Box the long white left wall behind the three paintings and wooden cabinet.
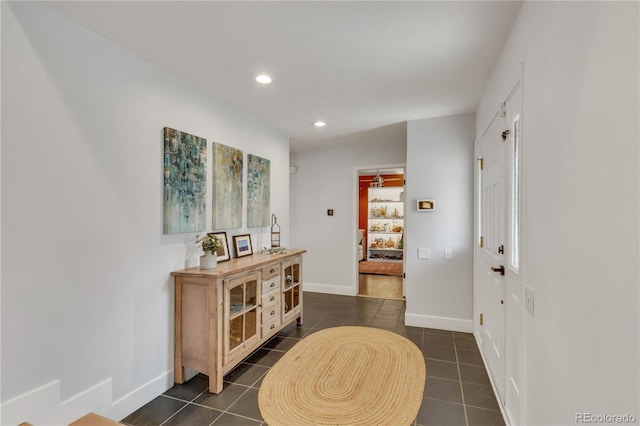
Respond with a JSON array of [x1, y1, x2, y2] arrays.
[[1, 2, 289, 424]]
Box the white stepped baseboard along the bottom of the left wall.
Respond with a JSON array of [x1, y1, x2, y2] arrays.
[[0, 370, 173, 426]]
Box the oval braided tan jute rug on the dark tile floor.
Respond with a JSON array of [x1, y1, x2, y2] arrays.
[[258, 327, 426, 426]]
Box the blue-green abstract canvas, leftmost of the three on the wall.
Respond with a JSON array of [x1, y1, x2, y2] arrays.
[[163, 127, 207, 234]]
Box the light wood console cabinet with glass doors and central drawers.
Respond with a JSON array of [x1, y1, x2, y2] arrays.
[[171, 250, 305, 394]]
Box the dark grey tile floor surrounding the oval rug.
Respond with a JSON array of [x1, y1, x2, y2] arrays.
[[121, 293, 504, 426]]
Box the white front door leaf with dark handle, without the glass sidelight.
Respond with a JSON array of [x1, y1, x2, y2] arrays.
[[476, 110, 507, 400]]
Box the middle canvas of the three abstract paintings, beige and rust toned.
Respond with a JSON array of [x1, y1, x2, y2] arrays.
[[212, 143, 244, 229]]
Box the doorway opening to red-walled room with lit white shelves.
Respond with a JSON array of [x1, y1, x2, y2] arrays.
[[356, 167, 404, 300]]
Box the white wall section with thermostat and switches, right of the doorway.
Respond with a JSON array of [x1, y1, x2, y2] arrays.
[[405, 114, 475, 331]]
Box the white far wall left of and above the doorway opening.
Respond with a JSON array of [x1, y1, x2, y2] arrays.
[[290, 123, 406, 295]]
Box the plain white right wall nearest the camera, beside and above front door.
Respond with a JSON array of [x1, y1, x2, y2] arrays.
[[477, 2, 640, 425]]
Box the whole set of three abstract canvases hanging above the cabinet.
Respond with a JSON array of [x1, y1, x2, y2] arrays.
[[163, 127, 271, 238]]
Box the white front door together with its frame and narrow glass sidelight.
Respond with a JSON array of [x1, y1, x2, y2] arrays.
[[475, 82, 524, 424]]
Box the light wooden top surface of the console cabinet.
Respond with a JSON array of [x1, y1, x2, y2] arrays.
[[171, 249, 306, 278]]
